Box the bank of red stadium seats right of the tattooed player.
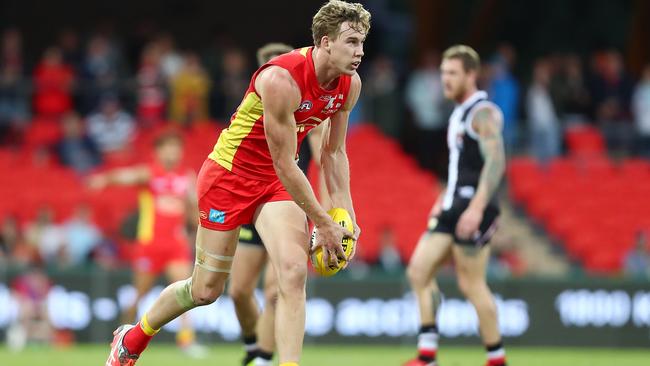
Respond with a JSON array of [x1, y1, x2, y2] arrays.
[[508, 155, 650, 273]]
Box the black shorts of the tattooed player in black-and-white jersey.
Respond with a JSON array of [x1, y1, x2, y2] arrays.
[[427, 198, 499, 247]]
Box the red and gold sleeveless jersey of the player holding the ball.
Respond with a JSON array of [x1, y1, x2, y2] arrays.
[[209, 47, 351, 181]]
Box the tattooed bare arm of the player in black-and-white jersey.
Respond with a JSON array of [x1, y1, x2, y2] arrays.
[[456, 107, 506, 239]]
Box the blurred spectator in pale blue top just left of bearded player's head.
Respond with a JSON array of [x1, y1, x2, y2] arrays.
[[405, 50, 447, 176]]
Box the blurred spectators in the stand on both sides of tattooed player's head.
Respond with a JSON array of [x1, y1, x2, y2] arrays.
[[363, 43, 650, 175]]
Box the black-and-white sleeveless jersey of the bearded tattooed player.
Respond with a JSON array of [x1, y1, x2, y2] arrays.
[[442, 90, 503, 210]]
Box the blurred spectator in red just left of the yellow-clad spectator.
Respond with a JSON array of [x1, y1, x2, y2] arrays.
[[136, 43, 166, 126]]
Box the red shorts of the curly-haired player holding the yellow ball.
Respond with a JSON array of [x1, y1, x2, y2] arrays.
[[196, 159, 293, 231]]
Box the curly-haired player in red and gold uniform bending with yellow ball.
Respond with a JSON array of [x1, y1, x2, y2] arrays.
[[106, 0, 370, 366]]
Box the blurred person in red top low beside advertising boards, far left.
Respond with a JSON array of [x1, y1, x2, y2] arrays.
[[7, 268, 54, 351]]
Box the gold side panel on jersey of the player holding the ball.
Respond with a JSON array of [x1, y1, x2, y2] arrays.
[[208, 92, 264, 171]]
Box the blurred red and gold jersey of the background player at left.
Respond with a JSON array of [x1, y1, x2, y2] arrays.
[[138, 163, 192, 244]]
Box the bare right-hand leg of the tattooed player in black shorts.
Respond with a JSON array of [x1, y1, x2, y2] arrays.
[[453, 245, 501, 345]]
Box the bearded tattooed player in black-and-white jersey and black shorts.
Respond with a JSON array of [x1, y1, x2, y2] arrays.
[[405, 45, 506, 366]]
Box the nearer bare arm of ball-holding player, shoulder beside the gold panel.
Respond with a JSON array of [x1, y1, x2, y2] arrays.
[[255, 66, 349, 262]]
